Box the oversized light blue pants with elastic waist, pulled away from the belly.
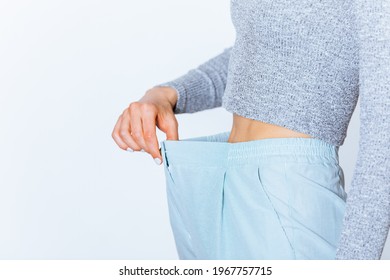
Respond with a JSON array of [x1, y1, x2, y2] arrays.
[[160, 131, 346, 259]]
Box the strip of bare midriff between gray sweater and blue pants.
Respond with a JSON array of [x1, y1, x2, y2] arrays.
[[227, 113, 311, 143]]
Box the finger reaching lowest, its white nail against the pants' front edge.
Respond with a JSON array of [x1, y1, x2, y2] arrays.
[[142, 111, 162, 164]]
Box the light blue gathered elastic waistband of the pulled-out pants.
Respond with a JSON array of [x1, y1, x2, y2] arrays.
[[160, 131, 338, 166]]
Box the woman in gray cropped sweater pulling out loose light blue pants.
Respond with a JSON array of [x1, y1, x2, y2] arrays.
[[112, 0, 390, 259]]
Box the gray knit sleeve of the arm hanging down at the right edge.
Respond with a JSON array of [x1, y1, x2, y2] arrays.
[[336, 0, 390, 259]]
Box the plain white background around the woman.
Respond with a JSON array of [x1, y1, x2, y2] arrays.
[[0, 0, 390, 259]]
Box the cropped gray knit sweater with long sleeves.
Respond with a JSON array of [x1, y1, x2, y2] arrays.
[[159, 0, 390, 259]]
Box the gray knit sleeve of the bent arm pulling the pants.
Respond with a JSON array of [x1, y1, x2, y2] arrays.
[[157, 47, 232, 114]]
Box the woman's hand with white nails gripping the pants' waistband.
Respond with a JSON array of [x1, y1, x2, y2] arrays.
[[112, 87, 179, 165]]
